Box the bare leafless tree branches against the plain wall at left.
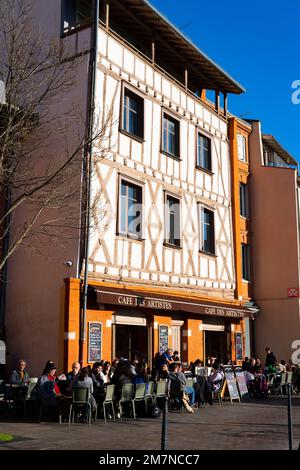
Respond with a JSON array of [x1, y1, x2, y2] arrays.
[[0, 0, 112, 271]]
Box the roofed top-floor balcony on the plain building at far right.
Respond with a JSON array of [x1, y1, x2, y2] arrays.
[[262, 134, 298, 170]]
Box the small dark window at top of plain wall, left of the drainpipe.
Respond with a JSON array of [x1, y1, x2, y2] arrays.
[[63, 0, 92, 32]]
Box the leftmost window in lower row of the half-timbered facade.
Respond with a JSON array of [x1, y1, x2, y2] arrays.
[[119, 180, 142, 238]]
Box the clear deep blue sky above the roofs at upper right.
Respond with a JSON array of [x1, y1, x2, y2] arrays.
[[149, 0, 300, 163]]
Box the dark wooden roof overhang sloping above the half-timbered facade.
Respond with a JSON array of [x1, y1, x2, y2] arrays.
[[109, 0, 245, 94]]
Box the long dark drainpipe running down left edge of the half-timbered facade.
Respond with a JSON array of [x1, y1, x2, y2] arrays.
[[79, 0, 100, 364]]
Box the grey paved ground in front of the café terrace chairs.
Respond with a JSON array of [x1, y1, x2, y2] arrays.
[[0, 396, 300, 450]]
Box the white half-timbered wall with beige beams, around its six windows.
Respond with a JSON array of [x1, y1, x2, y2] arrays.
[[89, 27, 235, 298]]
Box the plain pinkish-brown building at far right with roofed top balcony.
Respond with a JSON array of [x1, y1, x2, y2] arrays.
[[249, 121, 300, 360]]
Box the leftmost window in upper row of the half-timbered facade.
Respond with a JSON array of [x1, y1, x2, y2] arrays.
[[123, 88, 144, 139]]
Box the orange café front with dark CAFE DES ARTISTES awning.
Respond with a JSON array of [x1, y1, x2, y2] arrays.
[[65, 280, 253, 367]]
